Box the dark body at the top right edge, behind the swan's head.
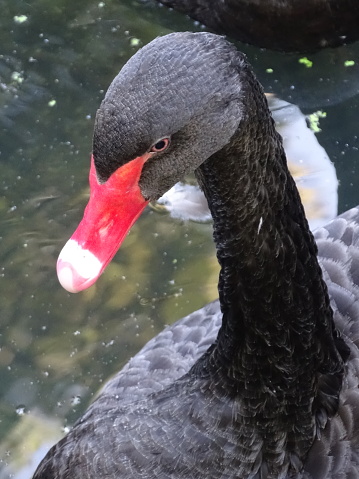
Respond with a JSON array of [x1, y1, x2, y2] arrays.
[[158, 0, 359, 52]]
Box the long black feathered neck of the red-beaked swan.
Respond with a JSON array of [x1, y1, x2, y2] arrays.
[[195, 79, 346, 472]]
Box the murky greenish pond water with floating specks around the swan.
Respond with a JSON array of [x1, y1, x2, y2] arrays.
[[0, 0, 359, 479]]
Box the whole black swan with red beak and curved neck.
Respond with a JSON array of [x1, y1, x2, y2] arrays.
[[34, 33, 359, 479]]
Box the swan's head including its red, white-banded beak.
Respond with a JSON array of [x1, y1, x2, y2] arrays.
[[57, 33, 248, 292]]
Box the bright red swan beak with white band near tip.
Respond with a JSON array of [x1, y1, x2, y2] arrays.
[[57, 154, 149, 293]]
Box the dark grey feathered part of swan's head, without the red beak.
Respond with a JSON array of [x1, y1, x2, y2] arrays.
[[93, 32, 243, 200]]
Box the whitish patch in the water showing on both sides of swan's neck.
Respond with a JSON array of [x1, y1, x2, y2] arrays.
[[154, 94, 338, 230]]
